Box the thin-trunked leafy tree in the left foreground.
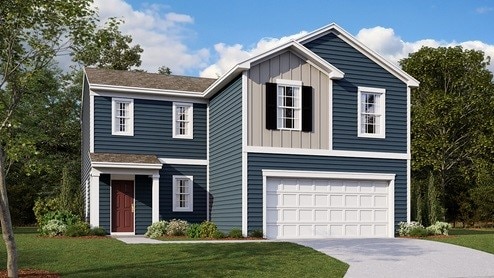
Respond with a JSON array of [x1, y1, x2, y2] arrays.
[[0, 0, 96, 277]]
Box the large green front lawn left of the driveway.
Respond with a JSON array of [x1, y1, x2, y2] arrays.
[[0, 228, 348, 277]]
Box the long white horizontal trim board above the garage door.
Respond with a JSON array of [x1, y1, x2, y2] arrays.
[[246, 146, 410, 160]]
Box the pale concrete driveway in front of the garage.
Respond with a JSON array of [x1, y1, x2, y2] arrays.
[[292, 238, 494, 278]]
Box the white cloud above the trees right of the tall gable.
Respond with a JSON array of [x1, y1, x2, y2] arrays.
[[356, 26, 494, 72]]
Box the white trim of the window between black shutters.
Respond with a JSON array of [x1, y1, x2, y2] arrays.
[[275, 79, 302, 131]]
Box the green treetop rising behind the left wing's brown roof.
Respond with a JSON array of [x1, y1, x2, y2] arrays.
[[75, 18, 143, 70]]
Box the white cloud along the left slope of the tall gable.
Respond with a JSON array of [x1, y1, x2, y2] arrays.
[[200, 31, 307, 78]]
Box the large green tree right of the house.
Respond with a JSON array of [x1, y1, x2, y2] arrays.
[[400, 46, 494, 224]]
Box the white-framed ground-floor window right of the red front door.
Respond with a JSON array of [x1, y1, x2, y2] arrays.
[[173, 176, 194, 211]]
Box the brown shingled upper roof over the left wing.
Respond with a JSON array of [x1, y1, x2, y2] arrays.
[[84, 68, 216, 94]]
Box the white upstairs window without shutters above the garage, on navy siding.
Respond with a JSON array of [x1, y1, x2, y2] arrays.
[[357, 87, 386, 138]]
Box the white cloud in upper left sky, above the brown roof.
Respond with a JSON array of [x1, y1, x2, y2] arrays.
[[94, 0, 210, 74]]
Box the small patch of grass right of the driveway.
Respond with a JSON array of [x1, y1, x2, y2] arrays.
[[427, 229, 494, 254]]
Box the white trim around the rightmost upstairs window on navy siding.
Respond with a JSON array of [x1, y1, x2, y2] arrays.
[[357, 86, 386, 138]]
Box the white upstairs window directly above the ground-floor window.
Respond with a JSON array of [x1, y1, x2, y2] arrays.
[[172, 102, 194, 139]]
